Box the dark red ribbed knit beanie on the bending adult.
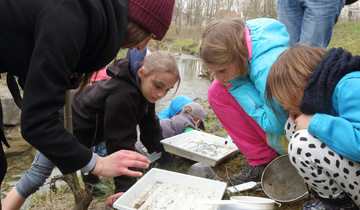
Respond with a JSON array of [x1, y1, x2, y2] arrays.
[[127, 0, 175, 40]]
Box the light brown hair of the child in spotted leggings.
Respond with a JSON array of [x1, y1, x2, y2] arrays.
[[265, 45, 326, 113]]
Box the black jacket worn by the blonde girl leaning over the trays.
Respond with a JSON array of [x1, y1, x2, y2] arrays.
[[72, 59, 163, 192]]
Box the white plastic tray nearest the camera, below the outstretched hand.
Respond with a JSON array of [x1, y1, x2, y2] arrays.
[[113, 168, 227, 210]]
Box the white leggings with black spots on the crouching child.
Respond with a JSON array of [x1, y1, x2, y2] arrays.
[[285, 129, 360, 208]]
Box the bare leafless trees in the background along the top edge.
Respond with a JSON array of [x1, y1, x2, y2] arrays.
[[170, 0, 276, 40]]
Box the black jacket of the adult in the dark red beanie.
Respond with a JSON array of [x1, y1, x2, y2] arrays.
[[0, 0, 127, 174]]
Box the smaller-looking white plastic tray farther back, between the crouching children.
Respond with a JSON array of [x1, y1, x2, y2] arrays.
[[161, 130, 239, 166]]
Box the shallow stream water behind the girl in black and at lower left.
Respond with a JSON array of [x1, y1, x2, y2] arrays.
[[1, 55, 210, 203]]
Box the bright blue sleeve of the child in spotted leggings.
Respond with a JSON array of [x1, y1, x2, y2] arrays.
[[308, 74, 360, 162]]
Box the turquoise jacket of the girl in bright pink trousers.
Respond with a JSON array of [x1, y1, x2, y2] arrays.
[[229, 18, 289, 135]]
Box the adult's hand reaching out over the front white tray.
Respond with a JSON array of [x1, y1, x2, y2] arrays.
[[91, 150, 150, 177]]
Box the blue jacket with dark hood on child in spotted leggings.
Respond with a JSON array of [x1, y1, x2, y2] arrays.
[[300, 48, 360, 162]]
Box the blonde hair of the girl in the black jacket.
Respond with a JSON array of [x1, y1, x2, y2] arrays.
[[142, 50, 181, 94]]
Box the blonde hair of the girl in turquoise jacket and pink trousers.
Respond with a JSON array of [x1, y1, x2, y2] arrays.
[[200, 18, 249, 77]]
